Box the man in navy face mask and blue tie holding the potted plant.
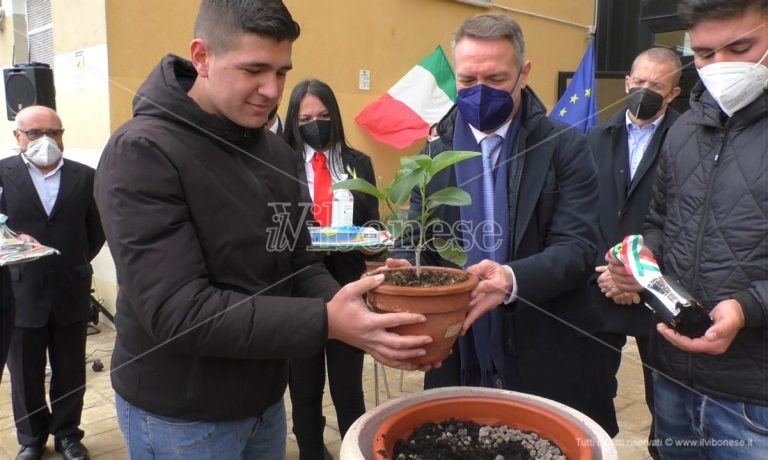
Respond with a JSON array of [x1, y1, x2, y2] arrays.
[[390, 14, 618, 434]]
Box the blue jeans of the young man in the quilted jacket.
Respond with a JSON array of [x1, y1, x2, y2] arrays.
[[653, 373, 768, 460]]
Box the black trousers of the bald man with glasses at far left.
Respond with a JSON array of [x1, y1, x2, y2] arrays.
[[8, 319, 87, 446]]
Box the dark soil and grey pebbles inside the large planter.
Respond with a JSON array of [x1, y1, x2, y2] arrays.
[[390, 419, 567, 460]]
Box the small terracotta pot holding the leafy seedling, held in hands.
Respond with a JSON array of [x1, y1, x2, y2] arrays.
[[368, 267, 479, 364]]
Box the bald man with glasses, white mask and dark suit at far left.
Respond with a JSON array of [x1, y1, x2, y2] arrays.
[[0, 106, 104, 459]]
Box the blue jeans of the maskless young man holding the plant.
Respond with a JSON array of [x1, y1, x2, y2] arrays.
[[115, 393, 286, 460]]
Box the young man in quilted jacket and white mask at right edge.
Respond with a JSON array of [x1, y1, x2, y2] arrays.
[[610, 0, 768, 459]]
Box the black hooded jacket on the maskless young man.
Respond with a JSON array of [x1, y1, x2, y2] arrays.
[[95, 55, 338, 421]]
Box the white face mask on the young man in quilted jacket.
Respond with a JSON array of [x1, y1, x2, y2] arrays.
[[698, 50, 768, 117]]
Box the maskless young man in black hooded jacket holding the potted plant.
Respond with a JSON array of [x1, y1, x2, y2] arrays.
[[96, 0, 431, 459]]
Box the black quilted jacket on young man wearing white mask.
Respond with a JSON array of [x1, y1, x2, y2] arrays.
[[644, 84, 768, 404]]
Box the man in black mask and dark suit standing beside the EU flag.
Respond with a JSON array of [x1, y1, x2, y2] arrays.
[[587, 48, 681, 456]]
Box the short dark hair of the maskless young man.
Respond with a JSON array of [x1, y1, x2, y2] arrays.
[[195, 0, 301, 53]]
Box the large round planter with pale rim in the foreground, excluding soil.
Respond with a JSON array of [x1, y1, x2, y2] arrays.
[[341, 387, 618, 460]]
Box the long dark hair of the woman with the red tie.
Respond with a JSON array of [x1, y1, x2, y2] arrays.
[[283, 79, 351, 177]]
